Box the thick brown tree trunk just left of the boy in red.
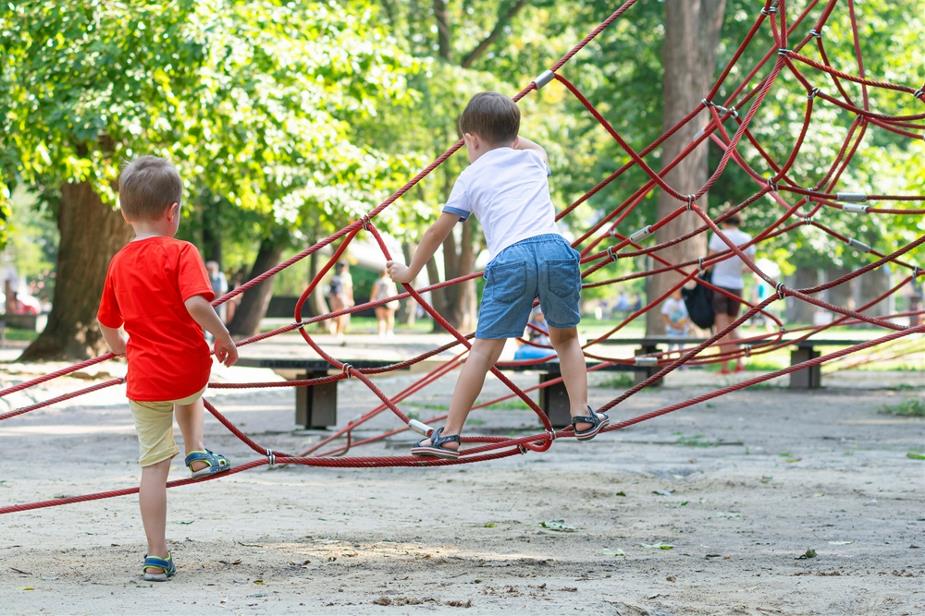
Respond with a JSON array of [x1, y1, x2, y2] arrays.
[[20, 182, 132, 361]]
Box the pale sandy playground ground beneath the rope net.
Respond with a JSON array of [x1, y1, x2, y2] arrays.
[[0, 344, 925, 616]]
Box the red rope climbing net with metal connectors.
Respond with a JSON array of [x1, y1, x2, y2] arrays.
[[0, 0, 925, 514]]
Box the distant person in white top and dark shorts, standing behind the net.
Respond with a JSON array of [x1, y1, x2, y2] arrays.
[[707, 214, 755, 374]]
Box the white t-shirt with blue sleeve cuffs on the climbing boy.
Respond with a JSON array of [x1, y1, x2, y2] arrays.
[[443, 148, 559, 259]]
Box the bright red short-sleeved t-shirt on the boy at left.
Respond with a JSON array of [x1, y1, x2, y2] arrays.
[[97, 236, 215, 402]]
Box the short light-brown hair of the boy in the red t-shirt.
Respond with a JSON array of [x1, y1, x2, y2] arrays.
[[119, 156, 183, 220]]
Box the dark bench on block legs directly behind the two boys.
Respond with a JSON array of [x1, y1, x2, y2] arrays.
[[235, 357, 639, 430]]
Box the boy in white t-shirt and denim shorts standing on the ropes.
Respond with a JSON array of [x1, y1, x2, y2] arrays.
[[387, 92, 609, 458]]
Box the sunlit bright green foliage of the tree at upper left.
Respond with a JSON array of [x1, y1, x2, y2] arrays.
[[0, 0, 420, 250]]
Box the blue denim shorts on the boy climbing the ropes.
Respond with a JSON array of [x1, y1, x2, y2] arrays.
[[475, 233, 581, 339]]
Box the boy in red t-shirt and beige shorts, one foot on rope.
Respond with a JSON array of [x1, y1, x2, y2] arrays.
[[97, 156, 238, 582]]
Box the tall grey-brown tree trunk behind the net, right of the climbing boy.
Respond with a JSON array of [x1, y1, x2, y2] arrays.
[[648, 0, 726, 336]]
